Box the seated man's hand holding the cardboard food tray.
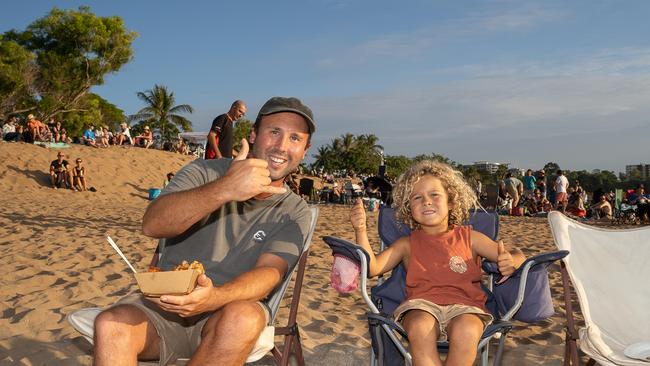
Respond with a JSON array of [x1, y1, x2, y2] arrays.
[[147, 274, 219, 318]]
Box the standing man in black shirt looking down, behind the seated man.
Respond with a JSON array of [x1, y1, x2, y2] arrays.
[[205, 100, 246, 159]]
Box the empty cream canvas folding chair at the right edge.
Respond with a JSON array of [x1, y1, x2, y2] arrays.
[[548, 212, 650, 365]]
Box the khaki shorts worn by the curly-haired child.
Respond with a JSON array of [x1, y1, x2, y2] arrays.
[[393, 299, 494, 342]]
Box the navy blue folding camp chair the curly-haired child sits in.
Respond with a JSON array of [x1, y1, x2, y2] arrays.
[[323, 207, 568, 366]]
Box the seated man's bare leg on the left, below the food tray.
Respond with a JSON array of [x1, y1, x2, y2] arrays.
[[93, 305, 160, 366]]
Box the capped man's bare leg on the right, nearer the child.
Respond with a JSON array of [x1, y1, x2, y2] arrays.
[[188, 301, 266, 366]]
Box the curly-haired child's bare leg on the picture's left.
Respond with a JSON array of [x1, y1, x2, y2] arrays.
[[402, 310, 442, 366]]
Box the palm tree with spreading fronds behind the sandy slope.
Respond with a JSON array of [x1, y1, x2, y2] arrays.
[[129, 85, 194, 142]]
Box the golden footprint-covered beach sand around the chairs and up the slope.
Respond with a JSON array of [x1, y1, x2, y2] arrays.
[[0, 143, 588, 366]]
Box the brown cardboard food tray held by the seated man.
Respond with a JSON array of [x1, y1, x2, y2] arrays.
[[135, 269, 201, 297]]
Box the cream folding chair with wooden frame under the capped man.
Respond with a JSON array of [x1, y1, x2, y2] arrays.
[[67, 206, 318, 366]]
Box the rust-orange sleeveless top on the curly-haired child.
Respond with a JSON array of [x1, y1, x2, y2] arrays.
[[406, 226, 487, 311]]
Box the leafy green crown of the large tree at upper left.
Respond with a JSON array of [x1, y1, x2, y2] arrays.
[[0, 6, 136, 120]]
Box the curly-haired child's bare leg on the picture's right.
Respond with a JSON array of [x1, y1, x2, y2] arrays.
[[445, 314, 483, 366]]
